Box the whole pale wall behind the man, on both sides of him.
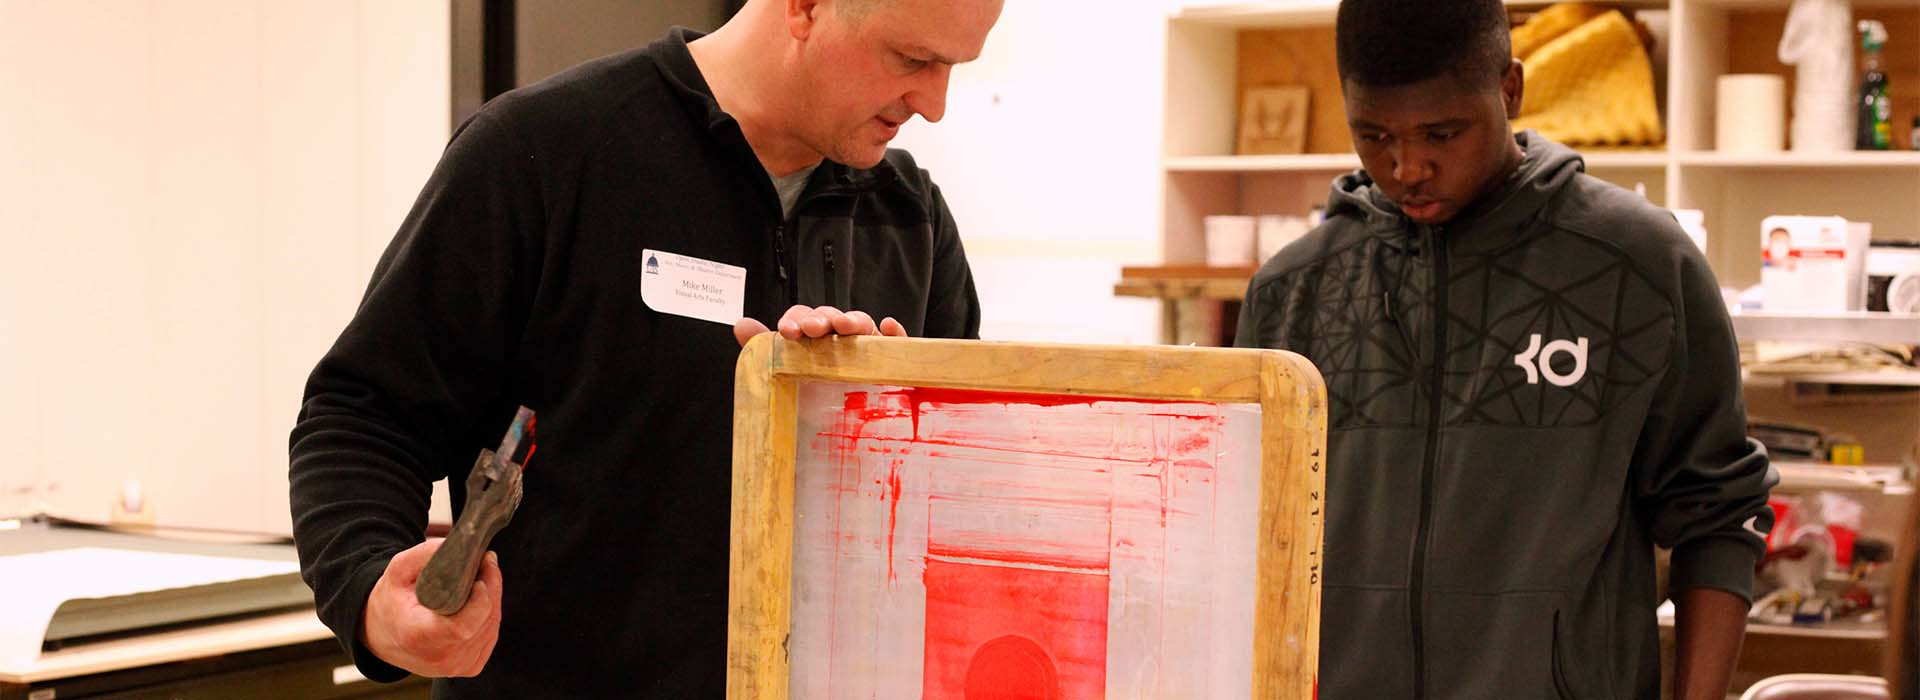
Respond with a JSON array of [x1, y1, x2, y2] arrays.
[[0, 0, 1177, 531]]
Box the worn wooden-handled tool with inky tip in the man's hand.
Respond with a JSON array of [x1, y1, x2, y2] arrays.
[[413, 407, 534, 616]]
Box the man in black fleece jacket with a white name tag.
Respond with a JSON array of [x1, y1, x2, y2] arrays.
[[288, 0, 1000, 698]]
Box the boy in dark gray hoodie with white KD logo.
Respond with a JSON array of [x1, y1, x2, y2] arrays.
[[1238, 0, 1778, 700]]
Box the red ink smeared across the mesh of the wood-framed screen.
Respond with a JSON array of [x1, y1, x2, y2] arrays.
[[812, 387, 1227, 700]]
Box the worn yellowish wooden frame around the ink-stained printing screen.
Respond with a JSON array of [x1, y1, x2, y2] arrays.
[[728, 334, 1327, 700]]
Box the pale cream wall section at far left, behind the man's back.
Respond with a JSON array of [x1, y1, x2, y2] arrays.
[[0, 0, 451, 531]]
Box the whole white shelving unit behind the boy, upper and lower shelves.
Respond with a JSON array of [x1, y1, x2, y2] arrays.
[[1160, 0, 1920, 675]]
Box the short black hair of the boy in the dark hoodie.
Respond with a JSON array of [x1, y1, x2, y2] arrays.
[[1334, 0, 1513, 88]]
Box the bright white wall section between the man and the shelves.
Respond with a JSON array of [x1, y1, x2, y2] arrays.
[[895, 0, 1181, 343]]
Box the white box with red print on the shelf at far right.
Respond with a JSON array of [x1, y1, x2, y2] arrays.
[[1761, 217, 1872, 313]]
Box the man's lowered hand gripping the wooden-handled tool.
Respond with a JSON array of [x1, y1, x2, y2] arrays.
[[359, 537, 503, 679]]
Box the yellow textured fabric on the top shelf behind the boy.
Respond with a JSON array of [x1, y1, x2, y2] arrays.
[[1513, 8, 1667, 146]]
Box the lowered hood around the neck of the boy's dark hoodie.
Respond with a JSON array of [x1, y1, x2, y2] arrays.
[[1327, 128, 1586, 253]]
